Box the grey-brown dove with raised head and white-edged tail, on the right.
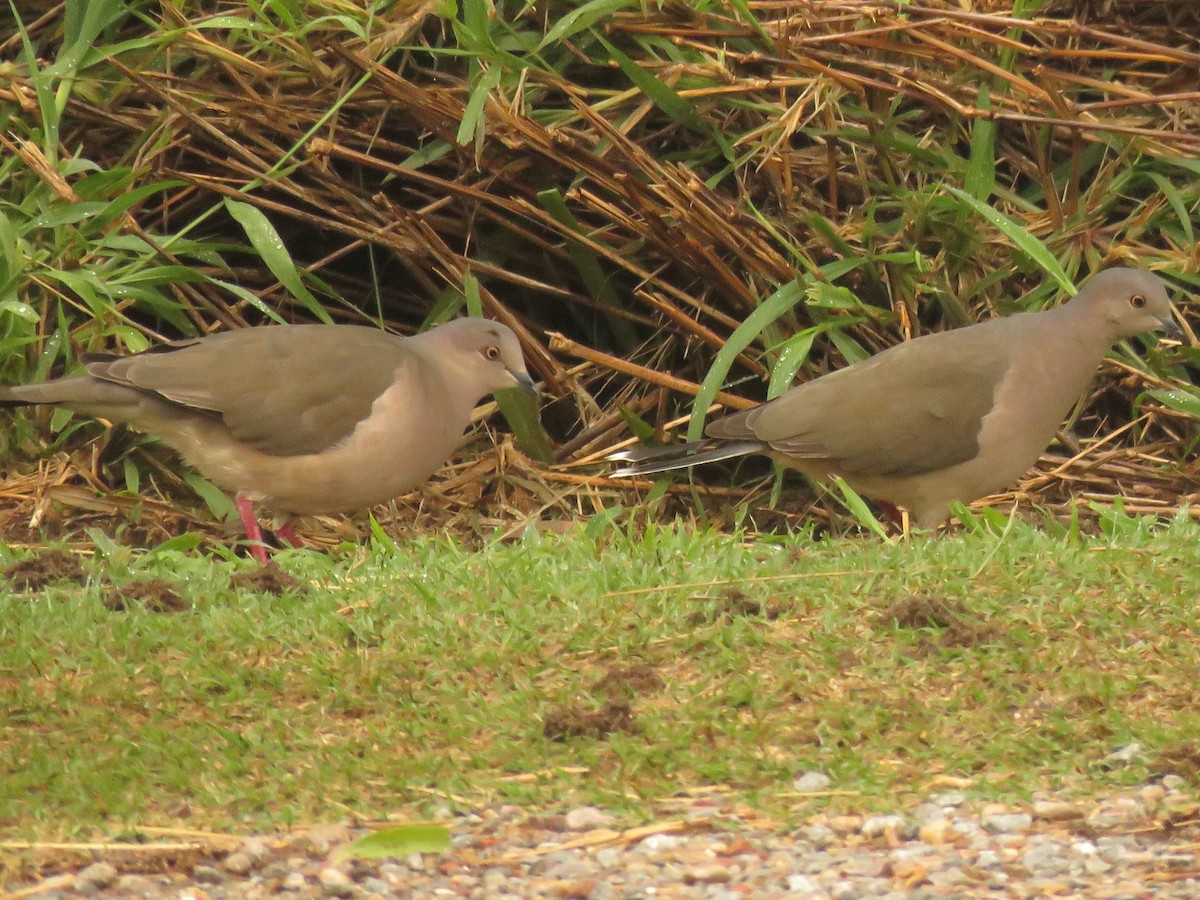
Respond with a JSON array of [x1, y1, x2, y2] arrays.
[[610, 269, 1182, 529]]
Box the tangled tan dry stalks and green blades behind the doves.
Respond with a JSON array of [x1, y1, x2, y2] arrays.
[[0, 0, 1200, 540]]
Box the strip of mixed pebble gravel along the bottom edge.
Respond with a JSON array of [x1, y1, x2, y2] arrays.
[[9, 776, 1200, 900]]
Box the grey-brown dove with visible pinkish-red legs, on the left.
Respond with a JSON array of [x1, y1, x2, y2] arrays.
[[0, 318, 535, 562]]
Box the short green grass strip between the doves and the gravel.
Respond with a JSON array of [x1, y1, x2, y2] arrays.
[[0, 516, 1200, 838]]
